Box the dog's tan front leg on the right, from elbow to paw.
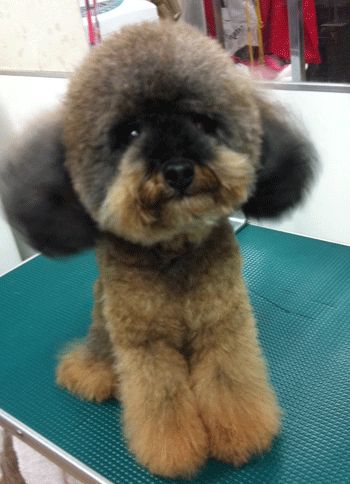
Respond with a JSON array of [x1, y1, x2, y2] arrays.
[[191, 290, 280, 466]]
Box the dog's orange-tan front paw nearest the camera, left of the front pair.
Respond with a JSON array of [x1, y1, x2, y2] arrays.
[[126, 404, 208, 478]]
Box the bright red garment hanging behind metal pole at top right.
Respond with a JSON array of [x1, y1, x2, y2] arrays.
[[260, 0, 321, 64]]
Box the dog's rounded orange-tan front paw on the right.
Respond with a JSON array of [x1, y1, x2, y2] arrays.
[[204, 401, 280, 467]]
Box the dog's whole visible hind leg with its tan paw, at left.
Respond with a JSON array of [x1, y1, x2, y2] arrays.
[[56, 280, 117, 402]]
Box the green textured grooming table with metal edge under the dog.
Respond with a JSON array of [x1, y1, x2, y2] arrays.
[[0, 226, 350, 484]]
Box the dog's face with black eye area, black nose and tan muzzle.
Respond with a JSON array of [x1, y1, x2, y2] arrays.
[[89, 96, 253, 245]]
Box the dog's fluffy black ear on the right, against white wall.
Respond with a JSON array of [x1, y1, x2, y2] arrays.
[[242, 99, 317, 218]]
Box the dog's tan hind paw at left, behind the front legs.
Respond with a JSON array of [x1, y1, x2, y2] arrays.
[[56, 344, 116, 402]]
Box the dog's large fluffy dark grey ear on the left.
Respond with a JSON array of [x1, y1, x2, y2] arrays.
[[0, 113, 97, 255]]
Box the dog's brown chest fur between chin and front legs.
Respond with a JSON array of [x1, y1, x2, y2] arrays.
[[97, 222, 246, 351]]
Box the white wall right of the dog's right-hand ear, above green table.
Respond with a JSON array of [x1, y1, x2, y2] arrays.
[[254, 90, 350, 245]]
